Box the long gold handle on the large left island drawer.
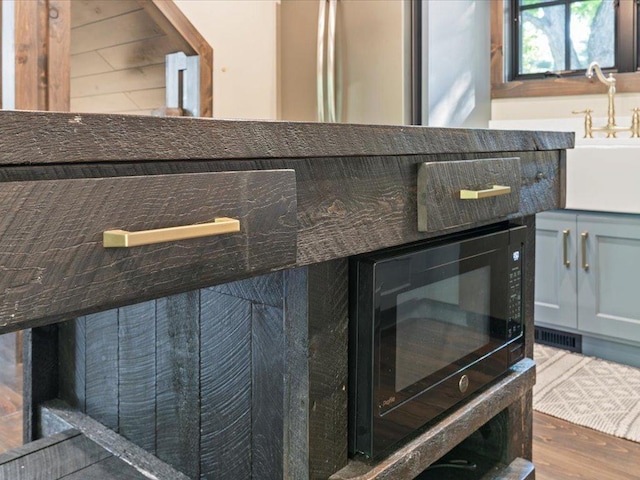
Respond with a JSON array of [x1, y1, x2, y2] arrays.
[[102, 217, 240, 248]]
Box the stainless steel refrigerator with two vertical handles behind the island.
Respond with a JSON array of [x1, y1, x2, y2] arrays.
[[277, 0, 421, 124]]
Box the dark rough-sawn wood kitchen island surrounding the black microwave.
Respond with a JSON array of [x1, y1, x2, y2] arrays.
[[0, 111, 574, 480]]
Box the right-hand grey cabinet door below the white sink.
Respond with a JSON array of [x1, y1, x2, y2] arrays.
[[578, 215, 640, 342]]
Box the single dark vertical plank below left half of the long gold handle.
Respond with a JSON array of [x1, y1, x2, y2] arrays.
[[118, 301, 156, 453]]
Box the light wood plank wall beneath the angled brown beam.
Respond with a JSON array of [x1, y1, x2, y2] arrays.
[[71, 0, 194, 114]]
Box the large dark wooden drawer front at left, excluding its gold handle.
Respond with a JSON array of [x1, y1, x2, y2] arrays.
[[0, 170, 297, 332]]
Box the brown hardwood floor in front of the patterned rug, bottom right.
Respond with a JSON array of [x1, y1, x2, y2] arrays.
[[533, 412, 640, 480]]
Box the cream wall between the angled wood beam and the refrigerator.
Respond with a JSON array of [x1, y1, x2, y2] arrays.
[[175, 0, 277, 119]]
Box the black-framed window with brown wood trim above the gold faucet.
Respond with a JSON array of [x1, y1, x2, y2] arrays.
[[491, 0, 640, 98]]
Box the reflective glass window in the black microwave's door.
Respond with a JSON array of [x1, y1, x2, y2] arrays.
[[376, 249, 507, 414]]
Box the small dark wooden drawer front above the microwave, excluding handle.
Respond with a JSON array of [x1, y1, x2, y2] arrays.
[[418, 158, 521, 232]]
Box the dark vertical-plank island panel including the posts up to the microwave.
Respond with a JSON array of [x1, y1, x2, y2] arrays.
[[55, 259, 348, 480]]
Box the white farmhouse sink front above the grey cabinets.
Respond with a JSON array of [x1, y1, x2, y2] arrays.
[[566, 145, 640, 213]]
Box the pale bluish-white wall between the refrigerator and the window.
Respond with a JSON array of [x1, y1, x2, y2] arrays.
[[422, 0, 491, 128]]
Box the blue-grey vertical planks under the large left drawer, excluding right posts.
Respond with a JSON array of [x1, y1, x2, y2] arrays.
[[58, 268, 307, 480]]
